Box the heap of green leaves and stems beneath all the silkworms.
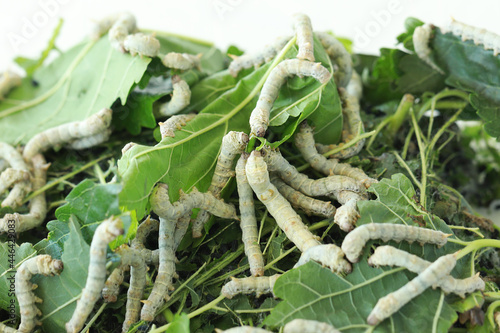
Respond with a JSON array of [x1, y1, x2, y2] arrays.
[[0, 13, 500, 332]]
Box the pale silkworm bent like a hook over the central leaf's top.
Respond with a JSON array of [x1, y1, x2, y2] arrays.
[[250, 59, 331, 137]]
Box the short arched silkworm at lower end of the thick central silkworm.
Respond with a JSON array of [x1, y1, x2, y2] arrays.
[[294, 244, 352, 273]]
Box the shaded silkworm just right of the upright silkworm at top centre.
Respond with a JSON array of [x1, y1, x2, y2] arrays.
[[315, 32, 354, 87]]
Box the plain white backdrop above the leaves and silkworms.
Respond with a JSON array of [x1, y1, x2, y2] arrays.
[[0, 0, 500, 71]]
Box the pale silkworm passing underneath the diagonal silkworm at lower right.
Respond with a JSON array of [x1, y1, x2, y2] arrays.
[[368, 245, 485, 298]]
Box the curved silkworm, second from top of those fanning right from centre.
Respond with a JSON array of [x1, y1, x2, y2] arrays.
[[264, 149, 364, 197]]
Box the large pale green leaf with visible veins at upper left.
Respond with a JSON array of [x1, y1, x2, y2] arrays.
[[0, 36, 151, 144]]
